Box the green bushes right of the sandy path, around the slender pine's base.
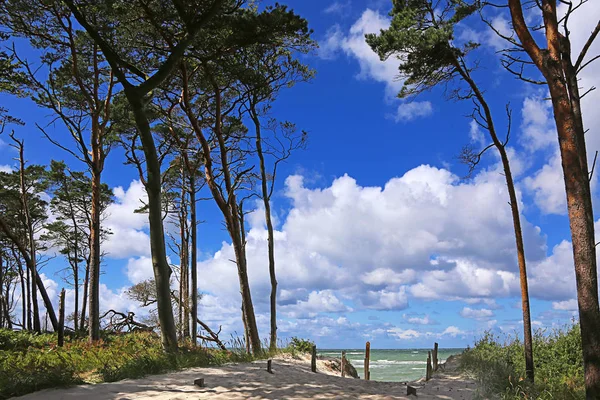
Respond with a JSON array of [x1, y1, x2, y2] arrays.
[[461, 324, 585, 399]]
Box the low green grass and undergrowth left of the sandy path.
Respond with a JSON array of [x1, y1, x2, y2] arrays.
[[0, 329, 276, 399]]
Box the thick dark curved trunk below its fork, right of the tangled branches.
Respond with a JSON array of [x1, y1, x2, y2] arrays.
[[125, 89, 177, 352]]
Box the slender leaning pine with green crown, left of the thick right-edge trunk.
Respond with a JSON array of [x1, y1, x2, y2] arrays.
[[366, 0, 534, 381]]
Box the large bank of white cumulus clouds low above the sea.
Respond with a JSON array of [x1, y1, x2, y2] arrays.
[[193, 165, 560, 340]]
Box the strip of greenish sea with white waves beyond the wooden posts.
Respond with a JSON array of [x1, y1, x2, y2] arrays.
[[318, 349, 464, 382]]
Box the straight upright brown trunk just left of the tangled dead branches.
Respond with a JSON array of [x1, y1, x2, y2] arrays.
[[88, 168, 101, 342]]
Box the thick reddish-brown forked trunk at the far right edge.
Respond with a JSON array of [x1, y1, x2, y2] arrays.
[[508, 0, 600, 399]]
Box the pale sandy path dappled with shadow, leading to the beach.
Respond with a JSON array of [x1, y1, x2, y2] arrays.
[[14, 357, 476, 400]]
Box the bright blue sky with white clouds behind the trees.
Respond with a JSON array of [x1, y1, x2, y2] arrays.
[[0, 0, 600, 348]]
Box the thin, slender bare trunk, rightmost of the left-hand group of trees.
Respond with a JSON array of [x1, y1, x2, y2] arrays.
[[251, 108, 277, 351]]
